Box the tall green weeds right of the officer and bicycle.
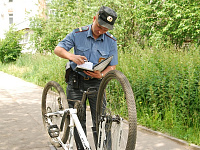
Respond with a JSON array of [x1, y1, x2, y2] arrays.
[[117, 42, 200, 144]]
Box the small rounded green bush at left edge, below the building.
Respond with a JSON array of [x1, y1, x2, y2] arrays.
[[0, 26, 23, 63]]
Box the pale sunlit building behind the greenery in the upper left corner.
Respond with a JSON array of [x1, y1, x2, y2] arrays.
[[0, 0, 48, 53]]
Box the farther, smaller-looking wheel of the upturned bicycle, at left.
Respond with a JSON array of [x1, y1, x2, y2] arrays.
[[42, 81, 69, 147]]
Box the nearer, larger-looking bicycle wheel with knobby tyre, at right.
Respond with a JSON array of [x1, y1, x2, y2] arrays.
[[96, 70, 137, 150]]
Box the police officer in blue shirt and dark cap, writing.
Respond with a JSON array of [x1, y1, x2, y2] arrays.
[[54, 6, 118, 150]]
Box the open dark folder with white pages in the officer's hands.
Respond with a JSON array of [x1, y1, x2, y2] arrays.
[[75, 56, 113, 72]]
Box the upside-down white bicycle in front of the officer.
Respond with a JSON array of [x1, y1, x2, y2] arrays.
[[42, 70, 137, 150]]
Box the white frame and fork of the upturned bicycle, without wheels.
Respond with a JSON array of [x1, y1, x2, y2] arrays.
[[46, 108, 122, 150]]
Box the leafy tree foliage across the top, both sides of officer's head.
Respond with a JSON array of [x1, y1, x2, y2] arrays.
[[28, 0, 200, 52]]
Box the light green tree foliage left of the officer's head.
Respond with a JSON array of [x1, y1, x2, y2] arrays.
[[28, 0, 95, 52]]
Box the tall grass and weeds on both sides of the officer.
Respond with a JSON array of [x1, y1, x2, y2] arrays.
[[0, 45, 200, 145]]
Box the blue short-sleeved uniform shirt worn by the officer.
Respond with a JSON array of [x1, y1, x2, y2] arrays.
[[58, 25, 118, 77]]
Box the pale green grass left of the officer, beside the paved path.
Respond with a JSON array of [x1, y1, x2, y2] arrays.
[[0, 54, 67, 87]]
